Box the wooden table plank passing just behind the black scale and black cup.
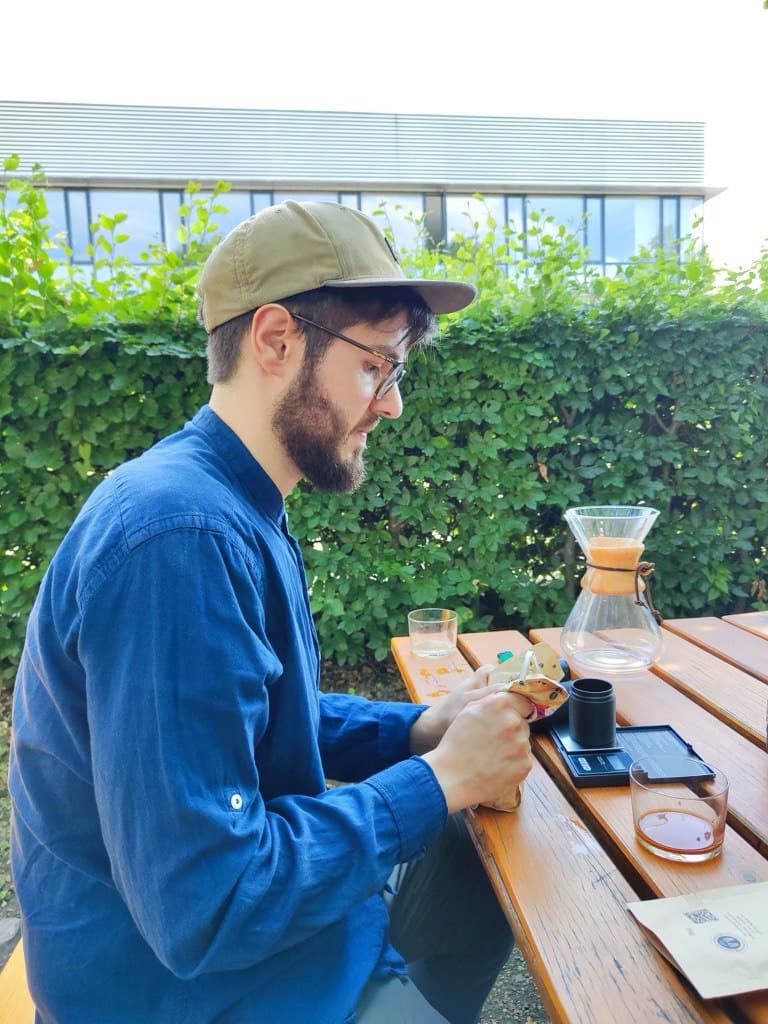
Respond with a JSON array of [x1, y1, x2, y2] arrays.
[[531, 629, 768, 853]]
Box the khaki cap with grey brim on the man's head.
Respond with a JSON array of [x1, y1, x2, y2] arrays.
[[198, 201, 477, 333]]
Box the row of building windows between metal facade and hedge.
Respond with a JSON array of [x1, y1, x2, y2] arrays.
[[27, 188, 705, 273]]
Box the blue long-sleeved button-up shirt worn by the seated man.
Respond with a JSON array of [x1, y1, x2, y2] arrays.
[[9, 407, 445, 1024]]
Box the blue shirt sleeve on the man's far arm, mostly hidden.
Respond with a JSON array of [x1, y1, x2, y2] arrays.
[[319, 693, 426, 782]]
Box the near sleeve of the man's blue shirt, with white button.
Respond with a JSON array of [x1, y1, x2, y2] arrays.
[[79, 528, 445, 978]]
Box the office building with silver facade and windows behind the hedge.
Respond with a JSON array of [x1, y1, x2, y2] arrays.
[[0, 101, 717, 271]]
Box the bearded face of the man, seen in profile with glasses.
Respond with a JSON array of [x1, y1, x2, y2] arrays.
[[272, 313, 407, 493]]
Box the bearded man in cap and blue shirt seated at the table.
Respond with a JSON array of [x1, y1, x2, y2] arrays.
[[10, 203, 529, 1024]]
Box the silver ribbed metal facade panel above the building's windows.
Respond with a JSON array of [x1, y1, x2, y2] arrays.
[[0, 101, 706, 193]]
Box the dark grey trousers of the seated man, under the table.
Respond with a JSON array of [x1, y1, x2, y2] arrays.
[[355, 815, 513, 1024]]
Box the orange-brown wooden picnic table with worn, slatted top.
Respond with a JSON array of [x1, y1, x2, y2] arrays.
[[392, 612, 768, 1024]]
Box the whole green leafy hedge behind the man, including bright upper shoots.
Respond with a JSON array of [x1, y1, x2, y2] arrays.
[[0, 169, 768, 672]]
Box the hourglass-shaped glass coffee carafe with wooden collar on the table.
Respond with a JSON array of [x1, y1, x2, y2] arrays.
[[562, 505, 662, 675]]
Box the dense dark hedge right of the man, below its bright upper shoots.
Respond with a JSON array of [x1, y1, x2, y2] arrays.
[[293, 299, 768, 658]]
